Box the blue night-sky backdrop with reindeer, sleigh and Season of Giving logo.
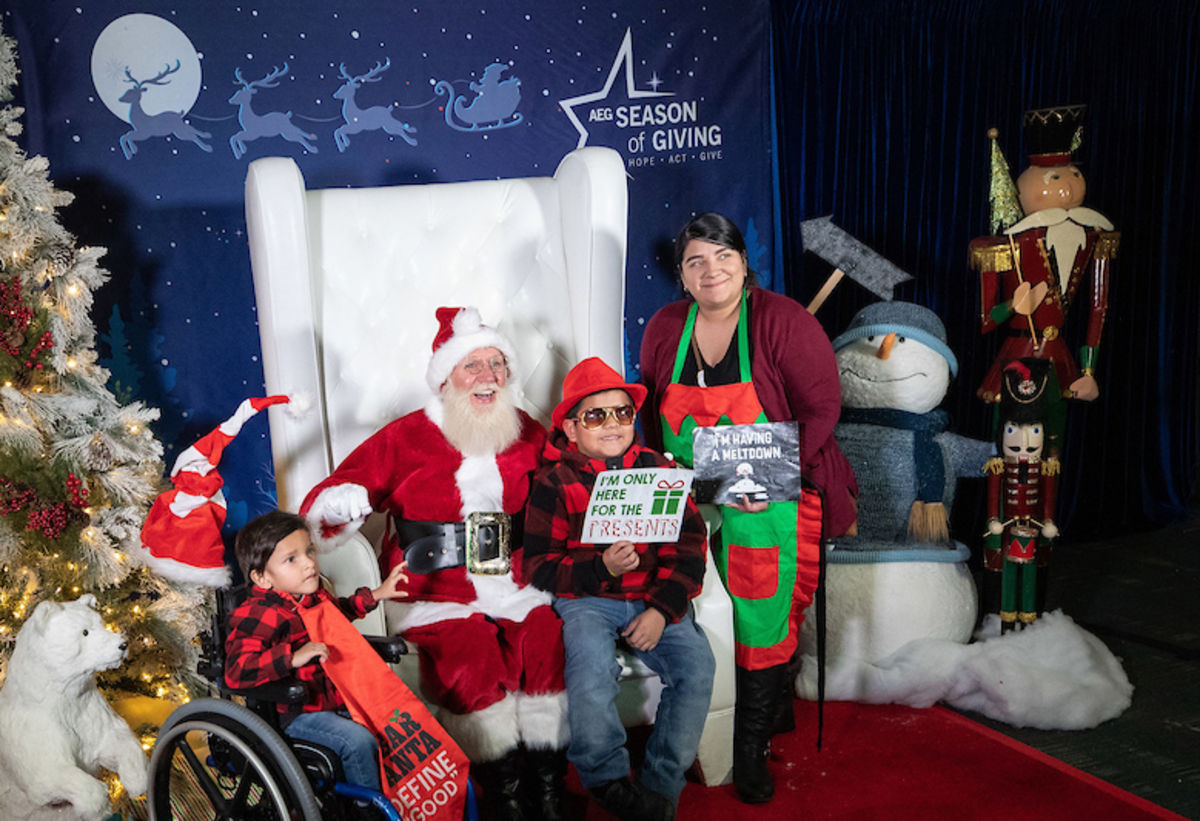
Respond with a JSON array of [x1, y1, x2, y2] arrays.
[[7, 0, 781, 529]]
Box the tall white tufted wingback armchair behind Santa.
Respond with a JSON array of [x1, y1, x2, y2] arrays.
[[246, 148, 733, 784]]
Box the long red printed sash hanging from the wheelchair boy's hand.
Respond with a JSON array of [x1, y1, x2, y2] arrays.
[[298, 600, 469, 821]]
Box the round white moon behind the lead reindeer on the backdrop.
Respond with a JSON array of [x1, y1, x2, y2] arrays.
[[91, 14, 200, 122]]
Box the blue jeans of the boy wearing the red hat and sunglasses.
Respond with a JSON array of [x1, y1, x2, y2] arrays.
[[554, 597, 714, 802]]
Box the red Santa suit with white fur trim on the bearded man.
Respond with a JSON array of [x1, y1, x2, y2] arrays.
[[300, 309, 568, 762]]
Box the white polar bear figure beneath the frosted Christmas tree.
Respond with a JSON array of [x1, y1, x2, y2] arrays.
[[0, 595, 146, 821]]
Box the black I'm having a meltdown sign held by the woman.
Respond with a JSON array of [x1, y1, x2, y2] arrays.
[[692, 421, 800, 504]]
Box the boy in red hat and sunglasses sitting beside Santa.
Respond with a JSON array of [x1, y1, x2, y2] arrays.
[[524, 356, 714, 820]]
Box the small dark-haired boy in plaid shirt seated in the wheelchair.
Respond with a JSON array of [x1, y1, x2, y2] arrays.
[[226, 510, 407, 790]]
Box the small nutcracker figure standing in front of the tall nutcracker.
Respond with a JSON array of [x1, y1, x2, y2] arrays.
[[984, 358, 1058, 633]]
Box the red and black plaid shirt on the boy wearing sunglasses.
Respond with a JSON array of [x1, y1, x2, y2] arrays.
[[522, 430, 708, 623]]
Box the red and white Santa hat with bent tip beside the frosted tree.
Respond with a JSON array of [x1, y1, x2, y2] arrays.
[[137, 396, 289, 587]]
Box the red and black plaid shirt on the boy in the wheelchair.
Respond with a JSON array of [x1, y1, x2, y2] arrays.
[[224, 585, 378, 719]]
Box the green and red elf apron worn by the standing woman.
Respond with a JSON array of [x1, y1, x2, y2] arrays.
[[659, 293, 821, 670]]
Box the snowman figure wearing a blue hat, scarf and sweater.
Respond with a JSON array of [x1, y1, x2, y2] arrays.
[[797, 302, 994, 701]]
